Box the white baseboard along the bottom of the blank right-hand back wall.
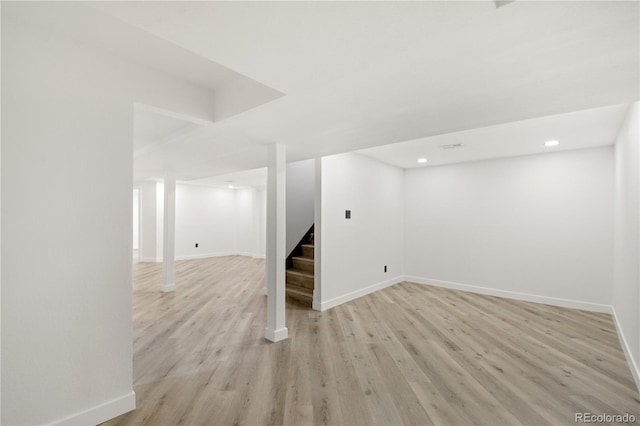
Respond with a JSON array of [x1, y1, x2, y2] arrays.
[[404, 276, 611, 314]]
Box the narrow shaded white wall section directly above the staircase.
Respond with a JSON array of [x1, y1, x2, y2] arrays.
[[286, 160, 315, 256]]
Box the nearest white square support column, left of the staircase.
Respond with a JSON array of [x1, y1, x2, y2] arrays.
[[264, 144, 289, 342]]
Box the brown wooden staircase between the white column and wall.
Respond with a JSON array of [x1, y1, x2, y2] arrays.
[[286, 233, 314, 307]]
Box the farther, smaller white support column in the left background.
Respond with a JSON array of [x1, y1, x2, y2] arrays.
[[161, 175, 176, 292]]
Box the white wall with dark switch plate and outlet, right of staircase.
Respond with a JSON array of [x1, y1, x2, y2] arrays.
[[314, 154, 404, 310]]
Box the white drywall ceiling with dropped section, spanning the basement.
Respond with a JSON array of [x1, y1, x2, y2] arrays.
[[11, 1, 640, 185]]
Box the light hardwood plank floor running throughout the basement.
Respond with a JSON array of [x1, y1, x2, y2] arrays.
[[106, 257, 640, 425]]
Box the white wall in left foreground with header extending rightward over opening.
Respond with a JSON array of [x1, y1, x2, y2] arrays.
[[1, 2, 222, 424]]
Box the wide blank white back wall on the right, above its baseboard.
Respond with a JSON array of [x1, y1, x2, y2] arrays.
[[404, 147, 613, 311]]
